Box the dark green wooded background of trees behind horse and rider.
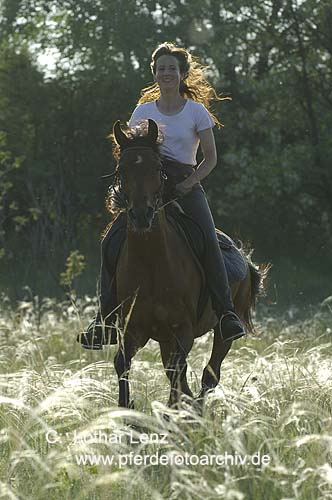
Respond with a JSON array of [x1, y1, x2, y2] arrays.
[[0, 0, 332, 307]]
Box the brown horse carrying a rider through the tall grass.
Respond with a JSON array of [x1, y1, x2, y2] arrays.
[[108, 120, 264, 407]]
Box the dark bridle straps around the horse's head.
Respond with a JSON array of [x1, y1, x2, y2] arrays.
[[104, 146, 169, 216]]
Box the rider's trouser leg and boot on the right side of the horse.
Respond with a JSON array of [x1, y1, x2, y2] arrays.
[[178, 185, 244, 340]]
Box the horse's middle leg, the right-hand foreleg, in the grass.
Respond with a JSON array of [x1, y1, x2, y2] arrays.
[[160, 339, 193, 407]]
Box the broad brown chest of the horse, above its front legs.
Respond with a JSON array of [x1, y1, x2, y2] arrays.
[[116, 231, 200, 338]]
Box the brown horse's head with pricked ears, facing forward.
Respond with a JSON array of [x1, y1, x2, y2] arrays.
[[113, 120, 164, 232]]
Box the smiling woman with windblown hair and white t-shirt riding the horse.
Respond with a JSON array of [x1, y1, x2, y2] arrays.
[[81, 42, 244, 348]]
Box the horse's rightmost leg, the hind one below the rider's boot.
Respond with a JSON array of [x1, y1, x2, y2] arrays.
[[198, 326, 232, 399]]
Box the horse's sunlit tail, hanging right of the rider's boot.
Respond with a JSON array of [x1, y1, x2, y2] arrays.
[[243, 253, 272, 333]]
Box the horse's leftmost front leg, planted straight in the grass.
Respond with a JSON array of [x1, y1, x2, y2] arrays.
[[114, 335, 147, 408]]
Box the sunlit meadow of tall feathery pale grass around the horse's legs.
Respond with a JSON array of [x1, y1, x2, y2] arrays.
[[0, 296, 332, 500]]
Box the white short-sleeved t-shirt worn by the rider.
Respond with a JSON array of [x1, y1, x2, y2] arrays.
[[129, 99, 214, 165]]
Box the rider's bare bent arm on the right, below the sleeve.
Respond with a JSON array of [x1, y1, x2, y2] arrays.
[[176, 128, 217, 194]]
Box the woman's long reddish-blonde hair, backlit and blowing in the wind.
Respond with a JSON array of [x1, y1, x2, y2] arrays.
[[138, 42, 231, 126]]
